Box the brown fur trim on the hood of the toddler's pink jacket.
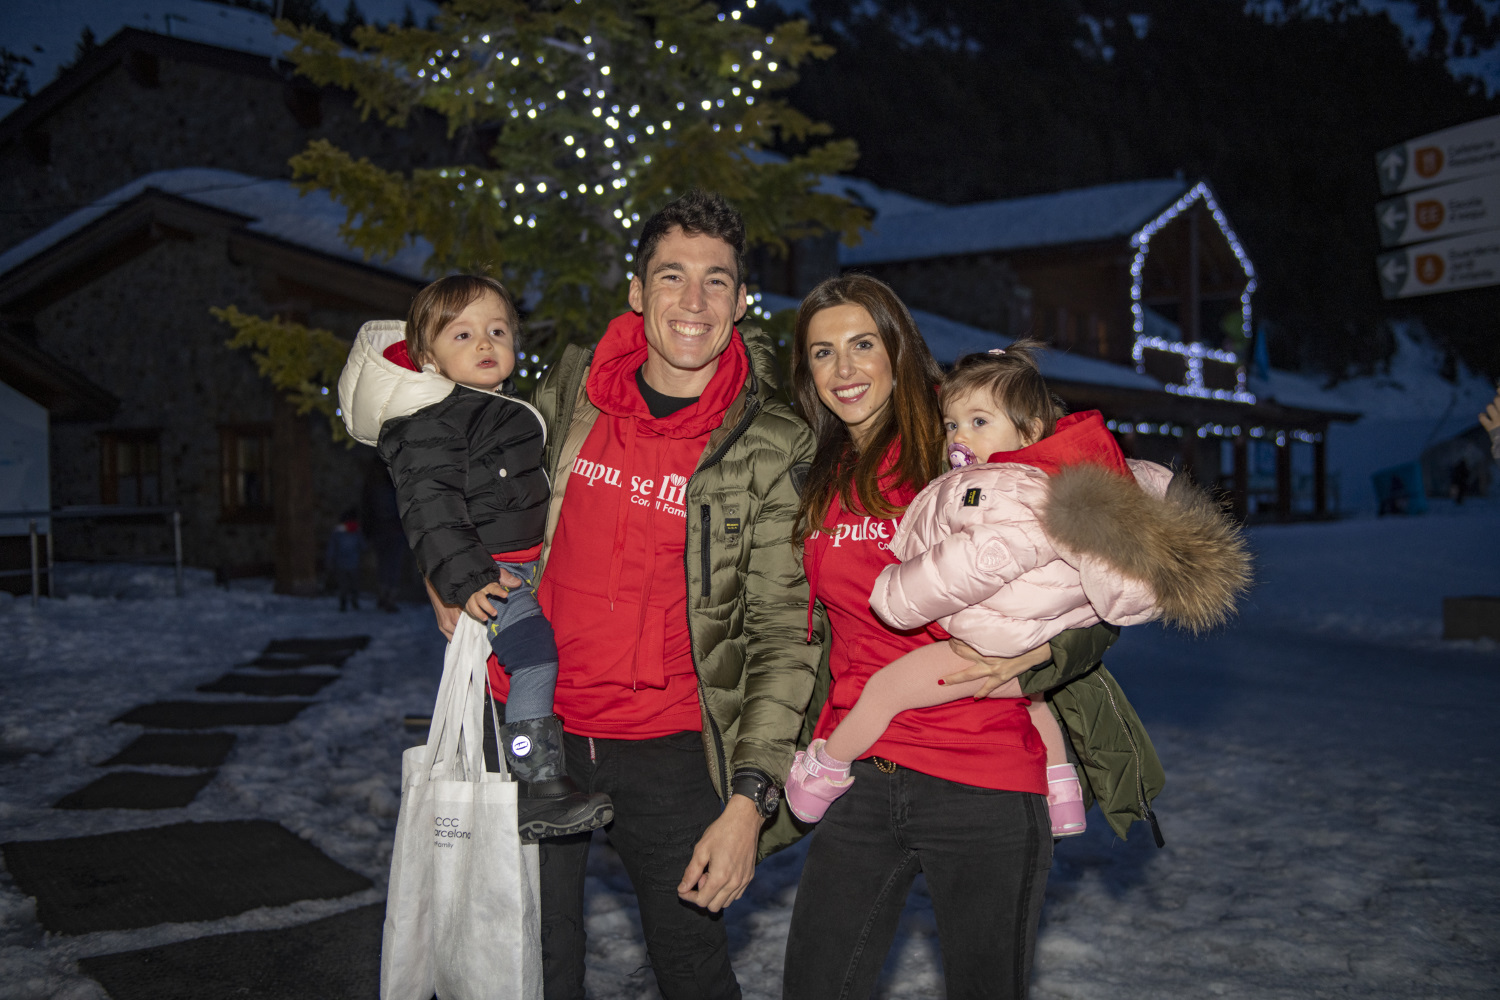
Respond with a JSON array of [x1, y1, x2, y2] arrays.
[[1041, 465, 1251, 634]]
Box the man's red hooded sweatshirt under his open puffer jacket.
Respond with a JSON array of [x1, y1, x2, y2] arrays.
[[491, 312, 750, 739]]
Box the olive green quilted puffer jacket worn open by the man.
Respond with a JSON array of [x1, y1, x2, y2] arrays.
[[534, 328, 822, 801]]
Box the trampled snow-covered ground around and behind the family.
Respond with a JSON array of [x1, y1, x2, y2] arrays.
[[0, 499, 1500, 1000]]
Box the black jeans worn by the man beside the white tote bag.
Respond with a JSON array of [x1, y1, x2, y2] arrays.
[[542, 732, 740, 1000]]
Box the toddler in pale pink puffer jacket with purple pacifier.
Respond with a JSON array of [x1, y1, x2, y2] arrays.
[[786, 342, 1248, 837]]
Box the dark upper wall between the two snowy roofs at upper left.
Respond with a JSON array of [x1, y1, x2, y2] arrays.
[[0, 54, 473, 249]]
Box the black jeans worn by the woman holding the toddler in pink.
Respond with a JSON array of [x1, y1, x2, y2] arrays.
[[782, 760, 1052, 1000]]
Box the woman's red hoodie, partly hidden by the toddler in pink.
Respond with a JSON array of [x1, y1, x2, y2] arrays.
[[803, 440, 1047, 795]]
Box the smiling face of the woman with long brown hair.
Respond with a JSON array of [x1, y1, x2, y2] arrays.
[[807, 303, 896, 448]]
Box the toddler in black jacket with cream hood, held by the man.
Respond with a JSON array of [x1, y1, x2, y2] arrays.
[[351, 274, 614, 840]]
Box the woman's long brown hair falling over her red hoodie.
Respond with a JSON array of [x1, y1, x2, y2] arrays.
[[792, 274, 944, 541]]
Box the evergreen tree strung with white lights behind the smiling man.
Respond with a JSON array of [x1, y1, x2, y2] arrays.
[[236, 0, 869, 425]]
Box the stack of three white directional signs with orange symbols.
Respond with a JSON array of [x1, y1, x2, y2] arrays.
[[1376, 115, 1500, 298]]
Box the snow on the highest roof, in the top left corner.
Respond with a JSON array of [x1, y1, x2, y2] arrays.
[[0, 0, 438, 117]]
